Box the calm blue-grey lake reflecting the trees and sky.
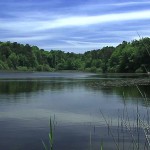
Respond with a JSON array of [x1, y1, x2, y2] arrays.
[[0, 72, 150, 150]]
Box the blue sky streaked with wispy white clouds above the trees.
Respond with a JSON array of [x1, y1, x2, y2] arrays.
[[0, 0, 150, 53]]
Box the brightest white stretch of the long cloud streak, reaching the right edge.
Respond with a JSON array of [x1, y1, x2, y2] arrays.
[[37, 10, 150, 30]]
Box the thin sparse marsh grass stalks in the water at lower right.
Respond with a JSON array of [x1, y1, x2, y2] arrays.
[[100, 86, 150, 150]]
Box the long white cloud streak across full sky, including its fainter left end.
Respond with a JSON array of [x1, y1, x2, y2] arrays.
[[0, 10, 150, 32]]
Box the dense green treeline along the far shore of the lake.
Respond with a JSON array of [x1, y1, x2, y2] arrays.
[[0, 38, 150, 73]]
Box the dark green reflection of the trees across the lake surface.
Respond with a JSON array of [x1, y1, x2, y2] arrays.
[[0, 78, 150, 105]]
